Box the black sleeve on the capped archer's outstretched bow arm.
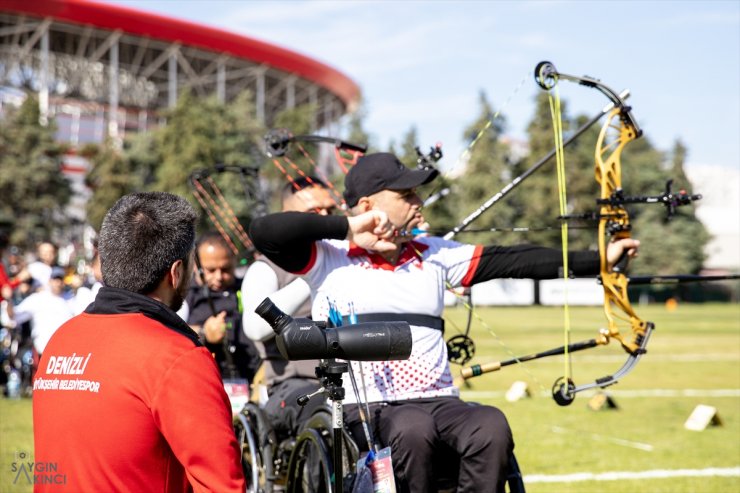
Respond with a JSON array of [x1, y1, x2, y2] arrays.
[[471, 245, 600, 284]]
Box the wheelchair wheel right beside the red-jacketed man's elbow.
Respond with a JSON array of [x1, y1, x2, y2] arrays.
[[234, 402, 275, 493]]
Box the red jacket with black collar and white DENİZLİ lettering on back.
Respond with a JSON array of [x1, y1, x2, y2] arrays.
[[33, 288, 245, 493]]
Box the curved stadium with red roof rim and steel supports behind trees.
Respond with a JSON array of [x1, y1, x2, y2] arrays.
[[0, 0, 360, 144]]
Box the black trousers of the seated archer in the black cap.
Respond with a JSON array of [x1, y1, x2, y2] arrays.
[[345, 397, 514, 493]]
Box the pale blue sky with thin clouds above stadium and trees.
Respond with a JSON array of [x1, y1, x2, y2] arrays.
[[109, 0, 740, 176]]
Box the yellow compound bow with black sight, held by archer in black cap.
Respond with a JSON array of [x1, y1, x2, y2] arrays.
[[456, 62, 701, 406]]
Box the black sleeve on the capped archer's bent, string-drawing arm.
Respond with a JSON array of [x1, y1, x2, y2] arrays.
[[249, 212, 349, 272]]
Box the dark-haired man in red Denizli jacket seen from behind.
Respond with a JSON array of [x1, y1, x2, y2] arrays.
[[33, 192, 245, 492]]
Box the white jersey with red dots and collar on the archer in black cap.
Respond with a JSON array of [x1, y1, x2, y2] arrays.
[[301, 237, 481, 403]]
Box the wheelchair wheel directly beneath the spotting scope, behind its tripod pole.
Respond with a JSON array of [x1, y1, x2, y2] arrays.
[[287, 409, 359, 493]]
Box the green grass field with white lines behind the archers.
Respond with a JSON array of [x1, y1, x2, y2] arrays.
[[0, 304, 740, 493]]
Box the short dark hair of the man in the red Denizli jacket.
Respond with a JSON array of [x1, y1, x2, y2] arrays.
[[98, 192, 197, 294]]
